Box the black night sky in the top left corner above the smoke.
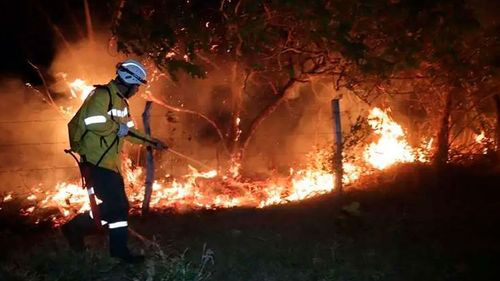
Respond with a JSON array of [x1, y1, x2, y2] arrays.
[[0, 0, 113, 82]]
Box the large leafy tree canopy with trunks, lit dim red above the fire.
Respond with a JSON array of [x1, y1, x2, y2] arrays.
[[114, 0, 496, 168]]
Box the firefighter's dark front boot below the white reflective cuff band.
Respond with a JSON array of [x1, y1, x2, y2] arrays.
[[109, 227, 144, 263]]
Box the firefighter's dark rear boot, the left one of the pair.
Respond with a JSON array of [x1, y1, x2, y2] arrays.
[[61, 213, 95, 252]]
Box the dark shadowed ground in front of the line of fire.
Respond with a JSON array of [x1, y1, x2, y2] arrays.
[[0, 165, 500, 281]]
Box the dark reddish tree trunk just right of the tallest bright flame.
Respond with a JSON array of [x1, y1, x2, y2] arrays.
[[434, 90, 453, 166]]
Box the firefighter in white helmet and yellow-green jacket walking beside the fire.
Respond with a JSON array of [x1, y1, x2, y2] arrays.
[[62, 60, 166, 263]]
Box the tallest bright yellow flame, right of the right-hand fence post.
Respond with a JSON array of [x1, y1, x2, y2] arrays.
[[364, 107, 415, 170]]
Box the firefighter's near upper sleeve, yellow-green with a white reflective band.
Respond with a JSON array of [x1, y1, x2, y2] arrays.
[[84, 90, 118, 136]]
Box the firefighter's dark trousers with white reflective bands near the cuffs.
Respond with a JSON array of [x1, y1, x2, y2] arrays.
[[64, 163, 129, 255]]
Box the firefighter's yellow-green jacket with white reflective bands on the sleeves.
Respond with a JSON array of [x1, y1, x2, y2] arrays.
[[79, 81, 150, 172]]
